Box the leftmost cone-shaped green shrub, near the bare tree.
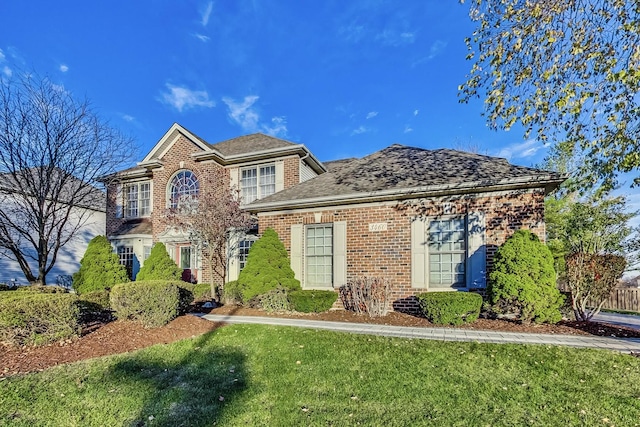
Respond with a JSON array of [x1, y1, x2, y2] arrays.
[[73, 236, 129, 295]]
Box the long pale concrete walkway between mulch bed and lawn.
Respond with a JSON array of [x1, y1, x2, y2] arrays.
[[198, 314, 640, 353]]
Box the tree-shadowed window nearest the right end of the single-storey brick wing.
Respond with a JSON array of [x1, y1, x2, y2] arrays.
[[428, 218, 466, 288]]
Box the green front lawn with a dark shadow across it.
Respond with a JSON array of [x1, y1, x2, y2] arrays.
[[0, 325, 640, 426]]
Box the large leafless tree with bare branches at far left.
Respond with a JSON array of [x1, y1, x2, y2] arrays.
[[0, 75, 132, 285]]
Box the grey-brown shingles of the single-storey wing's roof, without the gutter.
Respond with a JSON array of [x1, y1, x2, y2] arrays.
[[249, 144, 562, 207]]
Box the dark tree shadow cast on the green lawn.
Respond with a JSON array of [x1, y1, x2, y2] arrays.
[[108, 310, 246, 427]]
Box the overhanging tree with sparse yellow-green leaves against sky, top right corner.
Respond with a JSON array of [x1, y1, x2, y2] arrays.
[[460, 0, 640, 190]]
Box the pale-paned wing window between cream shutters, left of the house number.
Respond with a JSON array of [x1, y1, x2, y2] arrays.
[[305, 225, 333, 287]]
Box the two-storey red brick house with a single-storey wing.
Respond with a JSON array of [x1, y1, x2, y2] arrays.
[[107, 124, 563, 309]]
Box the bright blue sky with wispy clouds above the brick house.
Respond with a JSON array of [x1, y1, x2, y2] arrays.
[[0, 0, 546, 166]]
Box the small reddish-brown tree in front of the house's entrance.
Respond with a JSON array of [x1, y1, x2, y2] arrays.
[[167, 168, 253, 299]]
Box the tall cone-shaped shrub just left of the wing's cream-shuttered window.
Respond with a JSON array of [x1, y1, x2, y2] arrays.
[[238, 228, 300, 303]]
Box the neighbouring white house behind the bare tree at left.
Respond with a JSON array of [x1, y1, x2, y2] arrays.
[[0, 168, 106, 286]]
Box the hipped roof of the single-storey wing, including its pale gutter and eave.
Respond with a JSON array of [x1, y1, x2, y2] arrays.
[[247, 144, 564, 212]]
